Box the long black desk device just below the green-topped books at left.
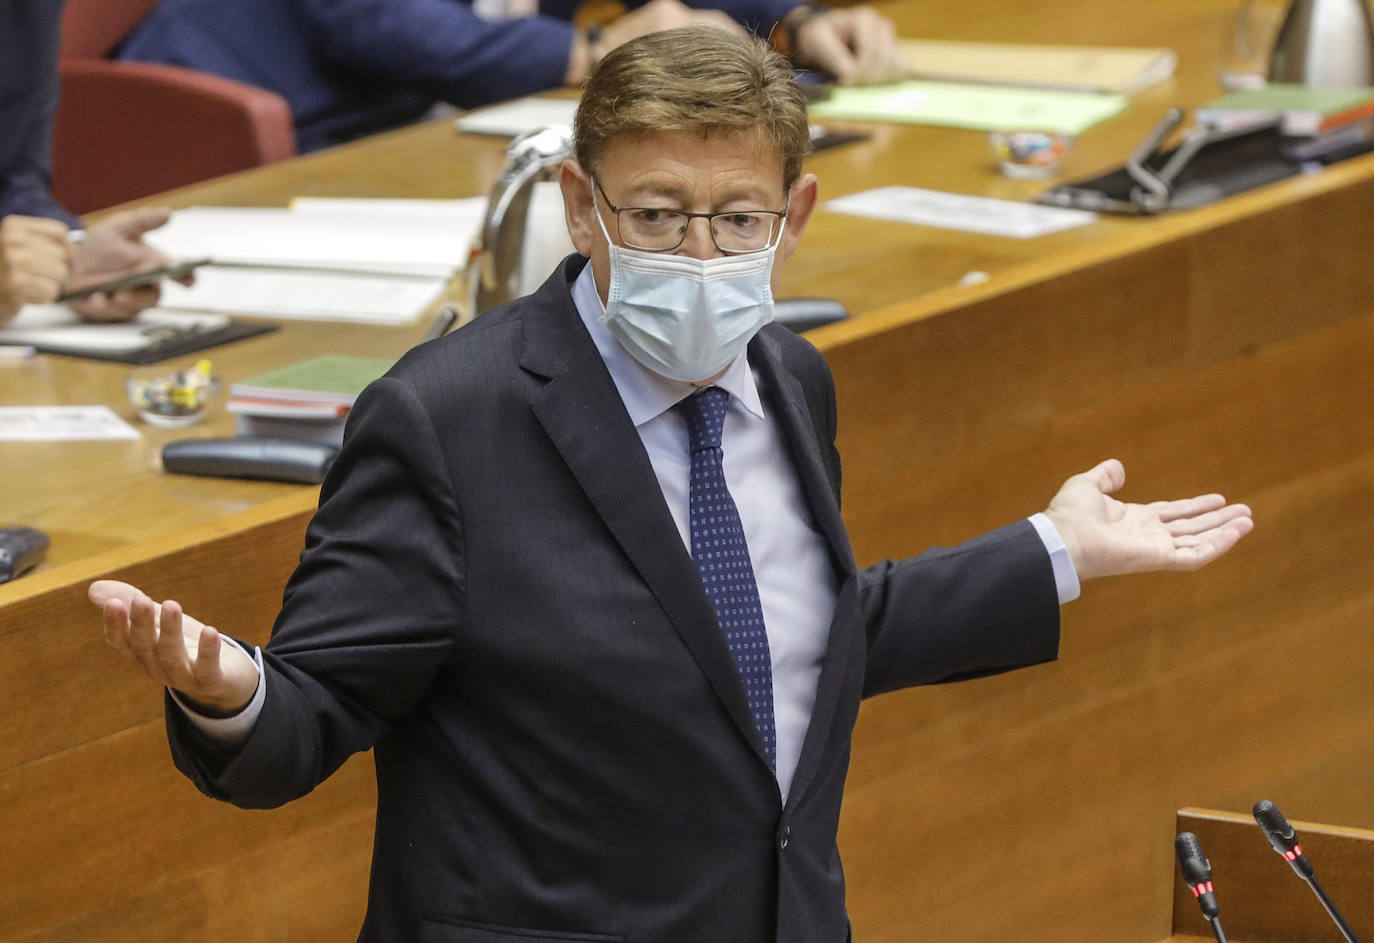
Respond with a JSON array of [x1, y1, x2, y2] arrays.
[[162, 436, 339, 484]]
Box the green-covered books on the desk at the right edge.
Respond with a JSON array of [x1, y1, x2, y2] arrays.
[[1194, 82, 1374, 161]]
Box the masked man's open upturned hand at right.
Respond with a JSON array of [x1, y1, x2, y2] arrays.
[[1044, 459, 1254, 580]]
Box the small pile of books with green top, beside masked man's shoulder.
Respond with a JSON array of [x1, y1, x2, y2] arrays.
[[225, 353, 394, 445]]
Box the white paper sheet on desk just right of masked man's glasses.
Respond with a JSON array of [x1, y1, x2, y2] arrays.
[[822, 187, 1098, 239]]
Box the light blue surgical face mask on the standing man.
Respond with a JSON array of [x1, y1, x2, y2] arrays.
[[592, 186, 782, 382]]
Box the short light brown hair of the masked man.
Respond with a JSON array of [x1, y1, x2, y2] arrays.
[[574, 26, 811, 187]]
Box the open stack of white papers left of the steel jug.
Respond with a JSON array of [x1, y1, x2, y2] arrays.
[[147, 198, 486, 323]]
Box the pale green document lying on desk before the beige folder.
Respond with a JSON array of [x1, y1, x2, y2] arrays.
[[811, 81, 1129, 135]]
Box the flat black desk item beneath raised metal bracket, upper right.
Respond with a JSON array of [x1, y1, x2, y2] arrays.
[[1035, 118, 1303, 214]]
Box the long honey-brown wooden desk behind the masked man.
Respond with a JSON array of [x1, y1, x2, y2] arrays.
[[0, 0, 1374, 943]]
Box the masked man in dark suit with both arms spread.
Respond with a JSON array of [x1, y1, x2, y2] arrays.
[[91, 29, 1250, 943]]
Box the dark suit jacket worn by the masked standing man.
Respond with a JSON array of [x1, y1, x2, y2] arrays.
[[169, 256, 1058, 943]]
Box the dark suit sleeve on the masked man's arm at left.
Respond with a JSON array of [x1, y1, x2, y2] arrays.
[[168, 378, 463, 808]]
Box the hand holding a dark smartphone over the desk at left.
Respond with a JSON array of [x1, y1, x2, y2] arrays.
[[69, 209, 172, 320]]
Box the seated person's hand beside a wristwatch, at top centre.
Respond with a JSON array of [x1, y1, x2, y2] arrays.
[[796, 7, 905, 85]]
